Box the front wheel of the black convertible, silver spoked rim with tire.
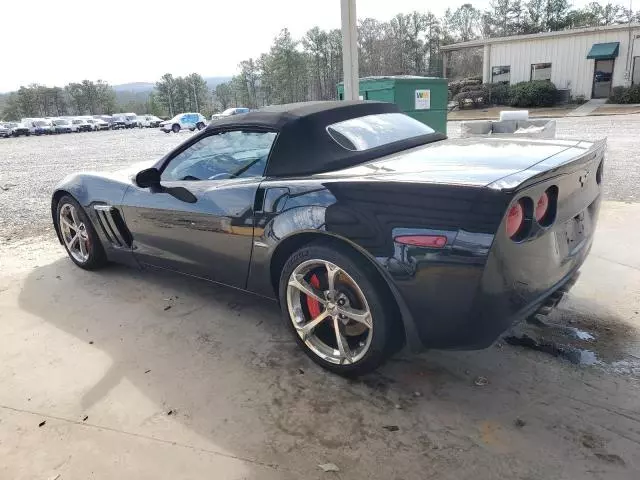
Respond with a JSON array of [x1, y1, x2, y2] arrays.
[[56, 195, 107, 270]]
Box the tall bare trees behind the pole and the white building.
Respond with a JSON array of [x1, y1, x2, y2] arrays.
[[213, 0, 640, 109]]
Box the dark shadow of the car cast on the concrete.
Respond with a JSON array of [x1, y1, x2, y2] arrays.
[[13, 258, 640, 478]]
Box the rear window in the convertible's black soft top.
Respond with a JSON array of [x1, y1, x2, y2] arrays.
[[327, 113, 434, 152]]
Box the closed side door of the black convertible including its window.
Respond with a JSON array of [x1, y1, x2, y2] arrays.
[[123, 129, 276, 288]]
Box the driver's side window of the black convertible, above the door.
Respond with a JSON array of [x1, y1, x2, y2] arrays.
[[162, 131, 276, 181]]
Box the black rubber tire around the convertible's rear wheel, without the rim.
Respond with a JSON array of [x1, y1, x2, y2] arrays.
[[279, 242, 404, 377]]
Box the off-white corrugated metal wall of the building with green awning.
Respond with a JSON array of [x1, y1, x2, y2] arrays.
[[491, 29, 640, 98]]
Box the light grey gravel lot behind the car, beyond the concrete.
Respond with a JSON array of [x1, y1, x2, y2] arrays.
[[0, 115, 640, 242]]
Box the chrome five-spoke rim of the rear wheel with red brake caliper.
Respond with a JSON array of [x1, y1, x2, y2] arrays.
[[287, 259, 373, 365]]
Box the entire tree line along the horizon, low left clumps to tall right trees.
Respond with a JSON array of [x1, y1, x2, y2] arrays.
[[3, 0, 640, 118]]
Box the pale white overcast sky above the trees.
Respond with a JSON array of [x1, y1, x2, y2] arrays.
[[0, 0, 638, 92]]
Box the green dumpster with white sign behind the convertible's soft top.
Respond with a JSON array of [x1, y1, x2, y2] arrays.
[[338, 75, 448, 134]]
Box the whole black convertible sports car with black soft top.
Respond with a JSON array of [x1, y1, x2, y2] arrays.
[[51, 102, 605, 375]]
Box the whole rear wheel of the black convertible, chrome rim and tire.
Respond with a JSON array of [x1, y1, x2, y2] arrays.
[[280, 244, 401, 376]]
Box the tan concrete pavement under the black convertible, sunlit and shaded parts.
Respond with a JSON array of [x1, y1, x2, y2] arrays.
[[0, 202, 640, 480]]
